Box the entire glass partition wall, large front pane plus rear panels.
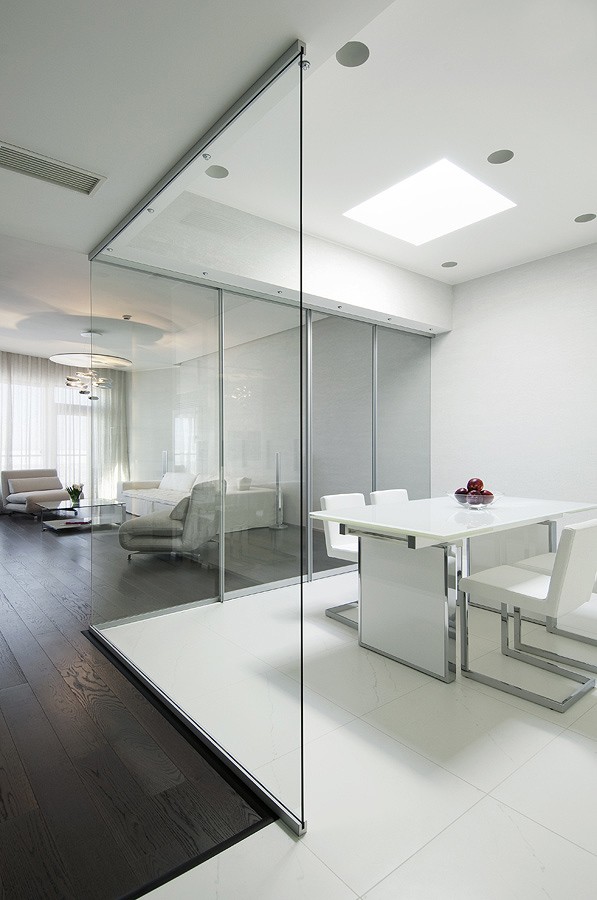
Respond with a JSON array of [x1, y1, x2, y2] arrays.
[[84, 42, 430, 833]]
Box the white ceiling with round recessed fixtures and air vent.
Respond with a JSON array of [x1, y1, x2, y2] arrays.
[[0, 0, 597, 355]]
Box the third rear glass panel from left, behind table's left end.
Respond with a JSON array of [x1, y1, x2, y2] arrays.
[[312, 316, 372, 572]]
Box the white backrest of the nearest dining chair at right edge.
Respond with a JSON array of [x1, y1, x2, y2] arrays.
[[546, 519, 597, 618]]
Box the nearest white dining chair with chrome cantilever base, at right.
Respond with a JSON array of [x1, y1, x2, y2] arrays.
[[459, 520, 597, 712]]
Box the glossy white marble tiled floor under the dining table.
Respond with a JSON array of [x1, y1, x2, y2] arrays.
[[103, 574, 597, 900]]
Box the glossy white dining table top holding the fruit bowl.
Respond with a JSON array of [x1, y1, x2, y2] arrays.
[[310, 497, 597, 543]]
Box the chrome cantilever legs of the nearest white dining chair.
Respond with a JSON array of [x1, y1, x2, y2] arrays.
[[460, 592, 595, 712]]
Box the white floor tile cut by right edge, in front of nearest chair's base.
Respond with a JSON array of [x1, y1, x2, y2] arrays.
[[492, 730, 597, 856]]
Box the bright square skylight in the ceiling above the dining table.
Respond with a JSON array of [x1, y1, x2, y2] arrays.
[[344, 159, 516, 247]]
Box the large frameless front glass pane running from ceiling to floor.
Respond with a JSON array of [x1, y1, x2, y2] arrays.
[[88, 47, 304, 830]]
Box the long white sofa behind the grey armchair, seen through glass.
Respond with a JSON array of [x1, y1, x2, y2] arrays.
[[118, 472, 276, 532]]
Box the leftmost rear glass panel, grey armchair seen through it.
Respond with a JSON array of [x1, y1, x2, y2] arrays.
[[87, 262, 219, 628]]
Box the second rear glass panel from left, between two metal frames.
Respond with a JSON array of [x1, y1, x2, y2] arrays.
[[224, 294, 301, 595]]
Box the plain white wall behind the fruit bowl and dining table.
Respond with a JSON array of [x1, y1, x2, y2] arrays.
[[431, 244, 597, 500]]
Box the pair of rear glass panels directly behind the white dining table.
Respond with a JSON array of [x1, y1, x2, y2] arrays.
[[309, 314, 431, 575]]
